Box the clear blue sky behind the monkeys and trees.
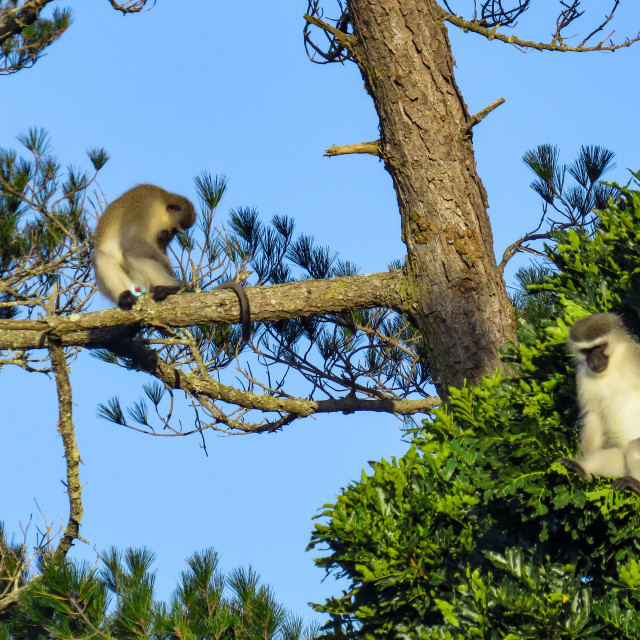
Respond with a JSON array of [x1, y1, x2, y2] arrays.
[[0, 0, 640, 619]]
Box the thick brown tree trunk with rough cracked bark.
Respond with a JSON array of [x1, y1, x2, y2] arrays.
[[349, 0, 514, 397]]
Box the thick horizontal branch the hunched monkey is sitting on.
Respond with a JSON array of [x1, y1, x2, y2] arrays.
[[0, 270, 412, 350]]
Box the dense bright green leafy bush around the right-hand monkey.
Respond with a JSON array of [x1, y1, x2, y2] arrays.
[[310, 174, 640, 640]]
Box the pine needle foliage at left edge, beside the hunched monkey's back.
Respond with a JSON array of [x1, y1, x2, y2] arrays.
[[0, 128, 99, 318]]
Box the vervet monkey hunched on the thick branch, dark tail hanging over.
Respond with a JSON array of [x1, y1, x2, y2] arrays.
[[93, 184, 250, 342]]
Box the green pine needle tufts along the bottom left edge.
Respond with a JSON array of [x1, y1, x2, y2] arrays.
[[0, 549, 314, 640]]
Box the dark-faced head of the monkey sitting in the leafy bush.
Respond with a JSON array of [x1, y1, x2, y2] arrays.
[[567, 313, 631, 374]]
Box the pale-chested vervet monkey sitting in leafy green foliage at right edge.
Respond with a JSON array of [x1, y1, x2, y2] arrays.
[[561, 313, 640, 493]]
